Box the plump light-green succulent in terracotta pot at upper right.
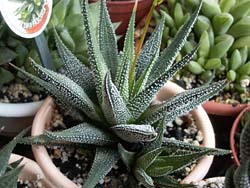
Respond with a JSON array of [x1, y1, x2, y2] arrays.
[[155, 0, 250, 117]]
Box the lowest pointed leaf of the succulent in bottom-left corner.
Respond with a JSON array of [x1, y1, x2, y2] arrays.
[[0, 166, 23, 188]]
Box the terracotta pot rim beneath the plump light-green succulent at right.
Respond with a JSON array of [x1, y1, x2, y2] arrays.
[[202, 101, 247, 117]]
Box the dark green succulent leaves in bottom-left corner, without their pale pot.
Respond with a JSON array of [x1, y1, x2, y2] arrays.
[[0, 129, 28, 188]]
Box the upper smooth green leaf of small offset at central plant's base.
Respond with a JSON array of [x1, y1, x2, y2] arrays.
[[136, 147, 164, 170]]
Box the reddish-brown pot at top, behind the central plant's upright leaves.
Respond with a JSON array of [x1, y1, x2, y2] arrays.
[[89, 0, 153, 35]]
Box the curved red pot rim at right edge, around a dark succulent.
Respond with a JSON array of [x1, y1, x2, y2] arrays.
[[230, 105, 250, 166]]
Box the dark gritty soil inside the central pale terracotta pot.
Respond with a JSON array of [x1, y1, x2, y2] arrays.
[[44, 107, 203, 188]]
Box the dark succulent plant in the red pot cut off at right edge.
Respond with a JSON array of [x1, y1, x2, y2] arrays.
[[225, 112, 250, 188]]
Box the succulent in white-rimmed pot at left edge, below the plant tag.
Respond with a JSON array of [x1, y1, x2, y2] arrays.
[[0, 17, 42, 136]]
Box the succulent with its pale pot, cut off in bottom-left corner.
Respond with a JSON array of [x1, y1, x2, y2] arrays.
[[0, 129, 51, 188]]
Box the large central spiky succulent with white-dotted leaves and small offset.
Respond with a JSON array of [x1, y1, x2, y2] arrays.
[[16, 0, 228, 188]]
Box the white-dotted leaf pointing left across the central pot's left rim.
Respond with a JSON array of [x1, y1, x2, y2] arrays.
[[22, 123, 117, 146]]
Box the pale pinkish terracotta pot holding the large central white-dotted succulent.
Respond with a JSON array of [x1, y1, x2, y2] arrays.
[[31, 82, 215, 188]]
